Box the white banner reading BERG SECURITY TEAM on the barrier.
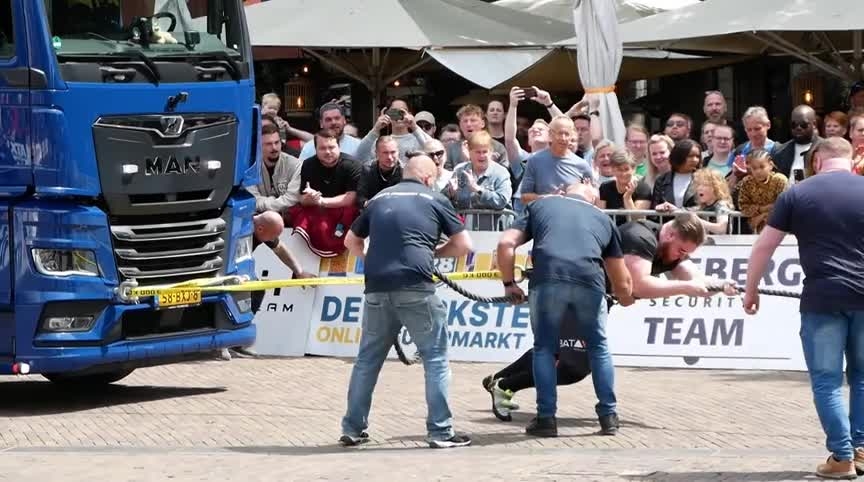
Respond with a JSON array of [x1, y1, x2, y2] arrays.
[[607, 246, 805, 370]]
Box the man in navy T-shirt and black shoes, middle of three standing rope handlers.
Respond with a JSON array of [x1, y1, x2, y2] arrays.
[[498, 184, 633, 437]]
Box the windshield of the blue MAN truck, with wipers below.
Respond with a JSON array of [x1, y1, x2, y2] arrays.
[[43, 0, 248, 62]]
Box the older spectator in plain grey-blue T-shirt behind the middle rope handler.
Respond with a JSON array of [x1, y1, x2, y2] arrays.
[[519, 115, 592, 204]]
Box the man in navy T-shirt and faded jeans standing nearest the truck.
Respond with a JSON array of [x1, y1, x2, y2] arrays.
[[339, 155, 471, 448]]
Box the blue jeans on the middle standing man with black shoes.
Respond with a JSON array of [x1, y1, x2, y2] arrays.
[[529, 282, 617, 418]]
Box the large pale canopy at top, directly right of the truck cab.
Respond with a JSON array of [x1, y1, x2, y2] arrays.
[[246, 0, 573, 50]]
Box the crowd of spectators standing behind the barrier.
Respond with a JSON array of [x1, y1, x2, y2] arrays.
[[250, 82, 864, 257]]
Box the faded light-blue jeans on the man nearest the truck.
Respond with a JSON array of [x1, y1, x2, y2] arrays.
[[342, 291, 454, 440]]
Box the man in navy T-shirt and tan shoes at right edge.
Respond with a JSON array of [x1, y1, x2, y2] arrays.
[[744, 137, 864, 479]]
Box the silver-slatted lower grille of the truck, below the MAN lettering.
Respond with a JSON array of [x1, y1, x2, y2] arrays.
[[111, 210, 230, 285]]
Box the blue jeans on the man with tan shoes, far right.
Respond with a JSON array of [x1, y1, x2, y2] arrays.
[[800, 311, 864, 460]]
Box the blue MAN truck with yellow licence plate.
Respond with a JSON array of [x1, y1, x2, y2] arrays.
[[0, 0, 260, 384]]
